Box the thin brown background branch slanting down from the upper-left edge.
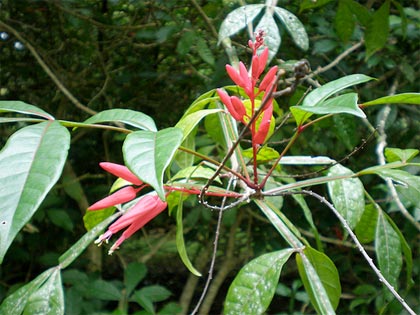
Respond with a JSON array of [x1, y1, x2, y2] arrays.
[[0, 20, 96, 115]]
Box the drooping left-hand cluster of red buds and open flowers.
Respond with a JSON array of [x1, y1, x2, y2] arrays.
[[88, 162, 167, 254]]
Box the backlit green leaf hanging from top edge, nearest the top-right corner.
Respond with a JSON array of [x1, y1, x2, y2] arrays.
[[365, 0, 389, 59]]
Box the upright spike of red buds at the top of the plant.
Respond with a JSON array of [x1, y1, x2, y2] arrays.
[[217, 32, 278, 144]]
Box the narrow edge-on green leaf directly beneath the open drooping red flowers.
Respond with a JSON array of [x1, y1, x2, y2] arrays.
[[58, 211, 121, 269]]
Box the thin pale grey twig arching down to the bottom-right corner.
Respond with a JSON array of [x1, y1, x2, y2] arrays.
[[296, 190, 416, 315]]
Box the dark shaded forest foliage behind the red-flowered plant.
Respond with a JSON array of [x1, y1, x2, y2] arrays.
[[0, 0, 420, 314]]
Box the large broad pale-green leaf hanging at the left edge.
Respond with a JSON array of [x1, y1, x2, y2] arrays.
[[0, 121, 70, 263]]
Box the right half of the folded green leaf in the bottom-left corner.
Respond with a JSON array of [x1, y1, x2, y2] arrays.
[[23, 268, 64, 315]]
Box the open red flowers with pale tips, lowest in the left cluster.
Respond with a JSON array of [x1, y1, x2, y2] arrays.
[[95, 193, 167, 255]]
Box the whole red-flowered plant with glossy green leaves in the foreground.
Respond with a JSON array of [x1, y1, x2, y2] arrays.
[[0, 30, 420, 314]]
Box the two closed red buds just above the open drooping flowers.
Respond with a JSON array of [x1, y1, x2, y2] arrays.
[[88, 162, 146, 210]]
